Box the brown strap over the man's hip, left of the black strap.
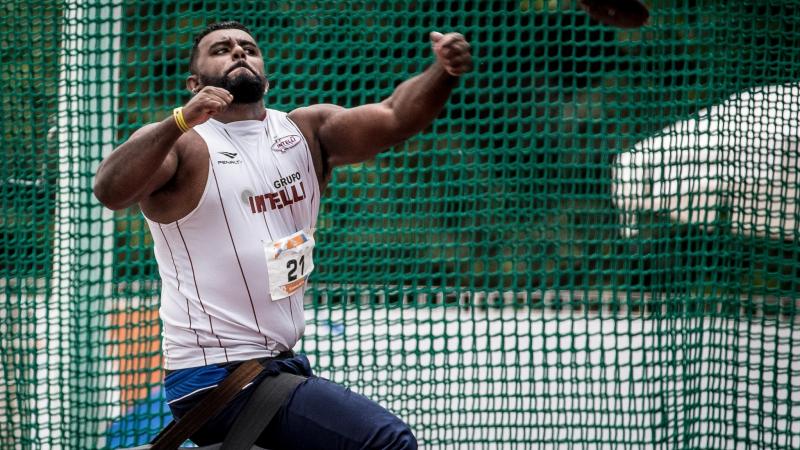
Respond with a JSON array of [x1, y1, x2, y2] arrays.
[[151, 360, 264, 450]]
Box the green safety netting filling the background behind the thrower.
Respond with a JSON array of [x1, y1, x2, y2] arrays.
[[0, 0, 800, 449]]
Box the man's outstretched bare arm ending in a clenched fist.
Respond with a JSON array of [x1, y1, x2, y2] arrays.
[[293, 32, 472, 168]]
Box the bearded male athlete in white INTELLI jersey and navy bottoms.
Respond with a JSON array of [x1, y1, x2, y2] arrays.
[[94, 22, 472, 449]]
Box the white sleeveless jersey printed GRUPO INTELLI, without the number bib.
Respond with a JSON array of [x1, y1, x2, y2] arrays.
[[147, 110, 320, 370]]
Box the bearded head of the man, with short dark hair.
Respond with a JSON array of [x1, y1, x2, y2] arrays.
[[196, 29, 268, 103]]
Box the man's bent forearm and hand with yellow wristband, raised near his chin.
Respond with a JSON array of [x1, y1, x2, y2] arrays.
[[94, 87, 233, 209]]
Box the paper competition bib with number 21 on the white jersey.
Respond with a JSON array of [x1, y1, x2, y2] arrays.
[[264, 230, 314, 301]]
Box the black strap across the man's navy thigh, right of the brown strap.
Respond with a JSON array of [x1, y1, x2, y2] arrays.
[[220, 373, 307, 450]]
